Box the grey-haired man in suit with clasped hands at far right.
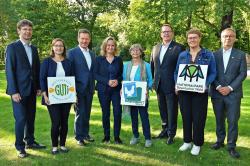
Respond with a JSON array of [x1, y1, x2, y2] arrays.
[[211, 28, 247, 158]]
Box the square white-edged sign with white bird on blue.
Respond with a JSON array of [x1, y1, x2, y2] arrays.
[[121, 81, 147, 106]]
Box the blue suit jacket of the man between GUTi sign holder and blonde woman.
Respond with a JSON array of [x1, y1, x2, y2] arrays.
[[67, 46, 95, 95]]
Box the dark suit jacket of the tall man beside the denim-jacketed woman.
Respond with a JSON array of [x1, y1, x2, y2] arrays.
[[151, 41, 184, 94]]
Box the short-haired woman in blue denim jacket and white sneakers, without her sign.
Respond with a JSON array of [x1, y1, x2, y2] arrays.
[[174, 29, 216, 155]]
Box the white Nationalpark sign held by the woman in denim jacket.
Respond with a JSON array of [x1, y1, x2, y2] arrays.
[[175, 64, 208, 93]]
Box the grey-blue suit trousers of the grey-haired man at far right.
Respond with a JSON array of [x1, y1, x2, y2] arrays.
[[212, 96, 241, 148]]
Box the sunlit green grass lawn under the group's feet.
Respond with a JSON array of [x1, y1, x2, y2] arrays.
[[0, 71, 250, 166]]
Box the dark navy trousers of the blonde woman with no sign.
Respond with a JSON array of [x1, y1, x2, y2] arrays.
[[98, 88, 122, 138]]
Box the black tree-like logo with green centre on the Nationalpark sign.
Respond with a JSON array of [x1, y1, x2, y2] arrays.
[[179, 65, 204, 82]]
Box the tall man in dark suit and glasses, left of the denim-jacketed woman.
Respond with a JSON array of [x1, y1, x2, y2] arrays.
[[151, 24, 184, 144]]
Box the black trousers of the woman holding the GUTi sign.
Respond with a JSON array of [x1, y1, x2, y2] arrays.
[[47, 104, 71, 147]]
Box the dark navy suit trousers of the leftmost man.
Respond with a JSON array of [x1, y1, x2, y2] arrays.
[[12, 94, 36, 150]]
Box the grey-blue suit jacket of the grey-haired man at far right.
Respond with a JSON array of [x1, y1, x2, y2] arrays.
[[211, 48, 247, 98]]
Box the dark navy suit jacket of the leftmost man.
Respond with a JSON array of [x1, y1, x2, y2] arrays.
[[5, 40, 40, 96]]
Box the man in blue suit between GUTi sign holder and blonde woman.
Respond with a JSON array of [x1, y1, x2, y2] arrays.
[[68, 29, 95, 146]]
